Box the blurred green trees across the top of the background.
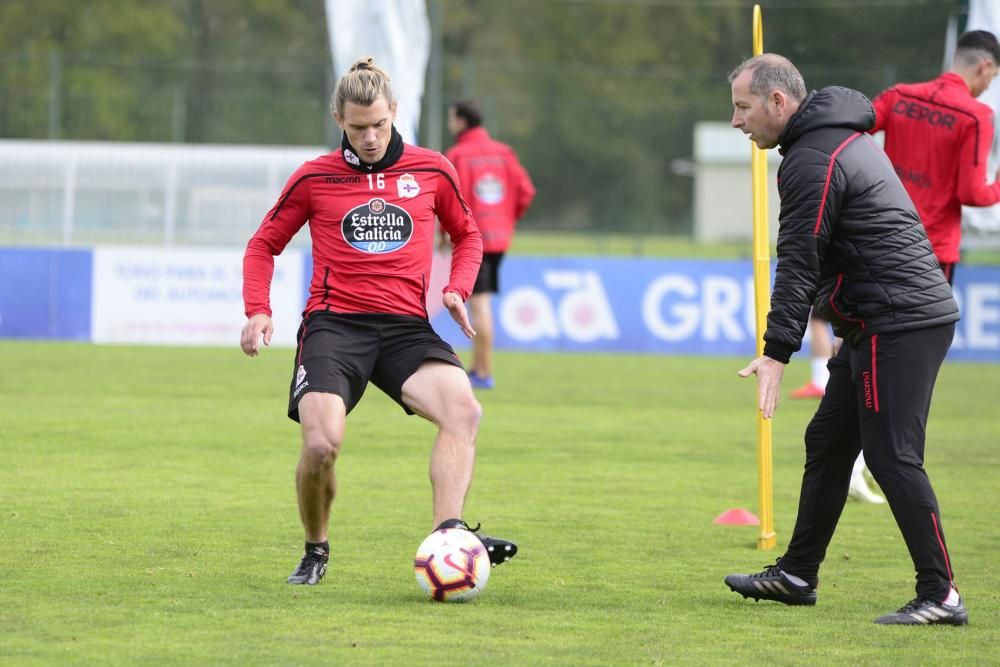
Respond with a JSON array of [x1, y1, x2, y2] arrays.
[[0, 0, 965, 234]]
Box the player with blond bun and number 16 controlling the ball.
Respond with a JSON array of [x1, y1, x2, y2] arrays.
[[240, 59, 517, 585]]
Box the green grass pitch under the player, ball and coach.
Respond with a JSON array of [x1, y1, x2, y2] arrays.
[[0, 341, 1000, 665]]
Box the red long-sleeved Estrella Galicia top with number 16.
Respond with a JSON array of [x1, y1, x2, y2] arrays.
[[243, 144, 483, 318]]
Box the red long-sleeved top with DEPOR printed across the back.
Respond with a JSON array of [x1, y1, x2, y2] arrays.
[[871, 72, 1000, 263]]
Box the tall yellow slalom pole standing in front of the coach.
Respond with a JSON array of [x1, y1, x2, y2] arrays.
[[750, 5, 777, 550]]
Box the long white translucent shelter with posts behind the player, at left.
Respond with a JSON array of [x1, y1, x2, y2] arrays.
[[0, 141, 326, 246]]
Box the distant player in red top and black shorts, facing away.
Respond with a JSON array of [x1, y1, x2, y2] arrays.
[[445, 100, 535, 389]]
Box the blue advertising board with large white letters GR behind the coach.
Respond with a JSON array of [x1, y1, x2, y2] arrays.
[[432, 257, 1000, 362]]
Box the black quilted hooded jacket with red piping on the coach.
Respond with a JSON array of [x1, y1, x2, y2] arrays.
[[764, 86, 958, 363]]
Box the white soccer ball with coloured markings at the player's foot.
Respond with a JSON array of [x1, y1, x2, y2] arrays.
[[413, 528, 490, 602]]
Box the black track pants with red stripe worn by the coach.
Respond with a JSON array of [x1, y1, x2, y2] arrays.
[[780, 324, 955, 602]]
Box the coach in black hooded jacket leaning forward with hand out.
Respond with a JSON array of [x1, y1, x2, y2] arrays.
[[726, 54, 968, 625]]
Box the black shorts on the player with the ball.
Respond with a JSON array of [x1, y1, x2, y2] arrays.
[[288, 312, 462, 421]]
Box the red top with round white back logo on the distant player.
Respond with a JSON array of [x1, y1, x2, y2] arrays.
[[445, 127, 535, 252]]
